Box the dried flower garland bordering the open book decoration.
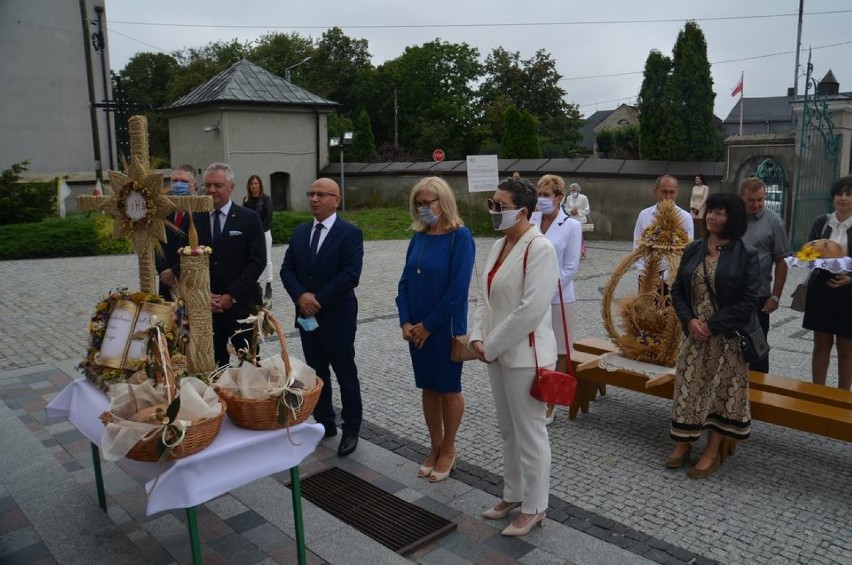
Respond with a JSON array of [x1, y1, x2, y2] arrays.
[[77, 288, 181, 391]]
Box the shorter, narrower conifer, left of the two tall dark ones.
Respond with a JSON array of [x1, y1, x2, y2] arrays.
[[638, 49, 672, 161]]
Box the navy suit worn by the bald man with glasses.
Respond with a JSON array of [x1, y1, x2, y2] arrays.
[[281, 217, 364, 434]]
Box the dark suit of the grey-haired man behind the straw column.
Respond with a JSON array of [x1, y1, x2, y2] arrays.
[[183, 202, 266, 366]]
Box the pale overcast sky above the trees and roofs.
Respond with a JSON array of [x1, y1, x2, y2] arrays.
[[106, 0, 852, 118]]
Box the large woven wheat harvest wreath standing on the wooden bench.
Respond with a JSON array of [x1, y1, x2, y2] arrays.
[[601, 200, 689, 367]]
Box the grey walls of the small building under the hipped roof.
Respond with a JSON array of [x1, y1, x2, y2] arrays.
[[169, 106, 328, 210]]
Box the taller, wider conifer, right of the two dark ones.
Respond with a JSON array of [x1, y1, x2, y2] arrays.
[[664, 21, 716, 161]]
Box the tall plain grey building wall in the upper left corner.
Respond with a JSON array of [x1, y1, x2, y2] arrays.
[[0, 0, 109, 176]]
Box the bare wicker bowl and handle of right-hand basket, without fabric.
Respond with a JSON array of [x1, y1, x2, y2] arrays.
[[216, 313, 323, 430]]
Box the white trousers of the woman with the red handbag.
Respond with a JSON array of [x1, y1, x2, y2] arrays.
[[488, 361, 553, 514]]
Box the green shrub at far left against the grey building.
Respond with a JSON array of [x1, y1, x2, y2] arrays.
[[0, 161, 56, 225]]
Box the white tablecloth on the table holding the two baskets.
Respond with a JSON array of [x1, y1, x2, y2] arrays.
[[45, 378, 325, 516]]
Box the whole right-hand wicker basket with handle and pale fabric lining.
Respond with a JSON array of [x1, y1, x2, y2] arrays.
[[216, 309, 323, 436]]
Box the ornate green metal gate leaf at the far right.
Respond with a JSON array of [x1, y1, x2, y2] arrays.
[[790, 55, 840, 247]]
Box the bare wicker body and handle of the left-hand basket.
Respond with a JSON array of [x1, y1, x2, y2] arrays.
[[101, 328, 228, 461]]
